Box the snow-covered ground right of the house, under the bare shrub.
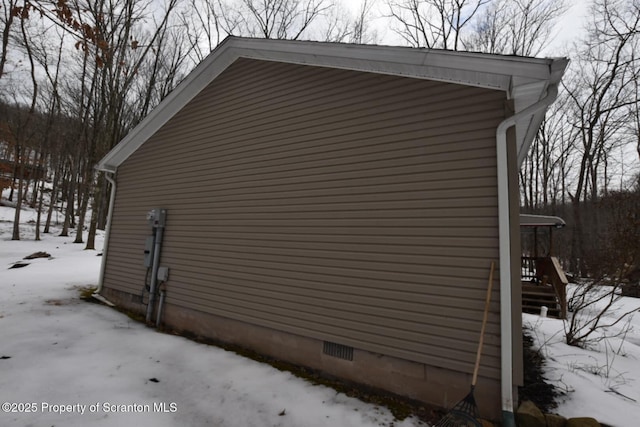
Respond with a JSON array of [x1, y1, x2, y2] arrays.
[[523, 285, 640, 427]]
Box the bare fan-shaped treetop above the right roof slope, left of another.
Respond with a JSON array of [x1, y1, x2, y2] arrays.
[[387, 0, 490, 50]]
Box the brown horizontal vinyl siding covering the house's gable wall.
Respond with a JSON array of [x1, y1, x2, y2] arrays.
[[104, 59, 505, 378]]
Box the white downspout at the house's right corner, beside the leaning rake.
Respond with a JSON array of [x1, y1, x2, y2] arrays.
[[496, 84, 558, 427]]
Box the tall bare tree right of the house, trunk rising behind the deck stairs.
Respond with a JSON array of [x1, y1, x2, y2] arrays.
[[565, 0, 640, 274]]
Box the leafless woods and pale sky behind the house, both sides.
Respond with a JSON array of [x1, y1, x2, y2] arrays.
[[0, 0, 640, 276]]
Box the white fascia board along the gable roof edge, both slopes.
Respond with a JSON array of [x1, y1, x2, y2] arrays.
[[96, 37, 564, 172]]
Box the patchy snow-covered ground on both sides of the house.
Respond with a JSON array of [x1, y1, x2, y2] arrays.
[[0, 200, 640, 427]]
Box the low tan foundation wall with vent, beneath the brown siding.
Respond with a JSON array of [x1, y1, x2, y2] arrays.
[[102, 289, 501, 420]]
